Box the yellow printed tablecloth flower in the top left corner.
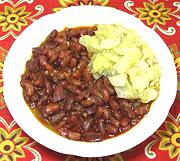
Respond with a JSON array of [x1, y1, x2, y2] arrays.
[[0, 6, 31, 32]]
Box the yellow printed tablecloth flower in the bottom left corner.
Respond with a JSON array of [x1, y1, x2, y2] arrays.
[[0, 128, 27, 161]]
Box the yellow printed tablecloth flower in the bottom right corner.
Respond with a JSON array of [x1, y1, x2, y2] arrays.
[[157, 121, 180, 159]]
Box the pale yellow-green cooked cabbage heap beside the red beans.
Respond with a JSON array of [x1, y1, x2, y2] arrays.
[[80, 24, 160, 103]]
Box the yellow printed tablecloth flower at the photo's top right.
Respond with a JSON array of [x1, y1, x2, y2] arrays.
[[136, 2, 171, 25]]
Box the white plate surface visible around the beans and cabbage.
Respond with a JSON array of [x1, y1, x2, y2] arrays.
[[3, 6, 177, 157]]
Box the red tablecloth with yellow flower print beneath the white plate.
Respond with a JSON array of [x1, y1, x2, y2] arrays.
[[0, 0, 180, 161]]
